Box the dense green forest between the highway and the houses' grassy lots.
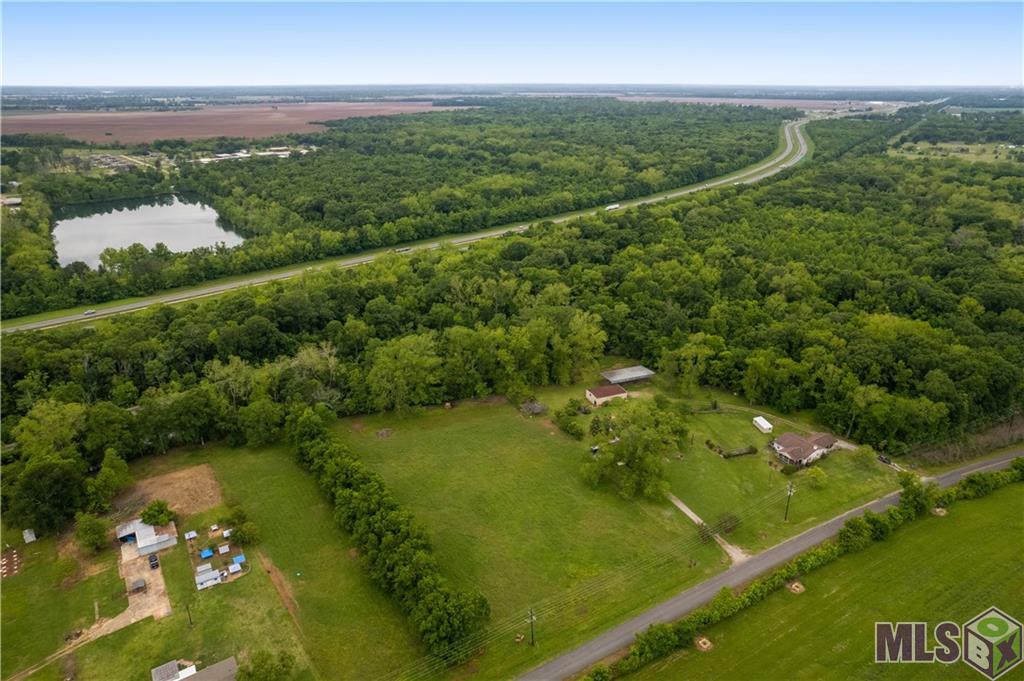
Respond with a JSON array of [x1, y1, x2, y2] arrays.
[[2, 144, 1024, 529]]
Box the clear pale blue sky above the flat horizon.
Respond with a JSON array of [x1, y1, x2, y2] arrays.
[[3, 2, 1024, 85]]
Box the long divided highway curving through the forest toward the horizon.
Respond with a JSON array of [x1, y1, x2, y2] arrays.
[[2, 119, 808, 333]]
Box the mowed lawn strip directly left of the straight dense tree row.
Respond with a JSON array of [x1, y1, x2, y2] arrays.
[[119, 445, 422, 679]]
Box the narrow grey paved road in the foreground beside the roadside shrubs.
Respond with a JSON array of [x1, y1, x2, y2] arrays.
[[520, 450, 1024, 681]]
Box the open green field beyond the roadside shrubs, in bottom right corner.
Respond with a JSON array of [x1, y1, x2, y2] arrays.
[[629, 484, 1024, 681]]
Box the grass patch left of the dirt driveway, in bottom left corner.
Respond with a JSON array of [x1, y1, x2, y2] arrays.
[[0, 528, 128, 678]]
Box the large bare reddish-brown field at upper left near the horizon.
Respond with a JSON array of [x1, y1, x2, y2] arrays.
[[3, 101, 460, 144]]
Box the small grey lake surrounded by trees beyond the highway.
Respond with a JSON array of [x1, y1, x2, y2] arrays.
[[53, 196, 243, 267]]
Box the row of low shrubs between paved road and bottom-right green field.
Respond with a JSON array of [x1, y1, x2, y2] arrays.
[[584, 458, 1024, 681]]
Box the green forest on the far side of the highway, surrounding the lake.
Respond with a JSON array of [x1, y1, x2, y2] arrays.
[[3, 98, 796, 318]]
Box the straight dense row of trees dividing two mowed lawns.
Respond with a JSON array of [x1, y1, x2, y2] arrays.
[[288, 409, 490, 664]]
